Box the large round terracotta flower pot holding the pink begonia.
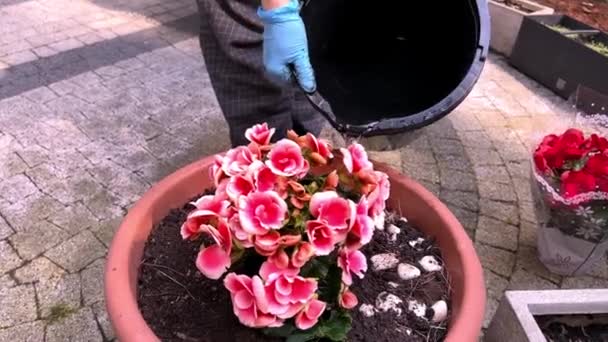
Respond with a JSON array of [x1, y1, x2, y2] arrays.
[[105, 158, 485, 342]]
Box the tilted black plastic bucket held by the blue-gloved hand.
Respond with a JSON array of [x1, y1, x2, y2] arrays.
[[302, 0, 490, 136]]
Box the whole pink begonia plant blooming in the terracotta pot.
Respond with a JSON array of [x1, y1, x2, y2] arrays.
[[181, 124, 390, 339]]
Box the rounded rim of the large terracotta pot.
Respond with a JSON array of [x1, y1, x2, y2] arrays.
[[104, 156, 485, 342]]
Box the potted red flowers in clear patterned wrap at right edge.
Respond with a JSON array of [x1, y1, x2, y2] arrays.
[[533, 129, 608, 275]]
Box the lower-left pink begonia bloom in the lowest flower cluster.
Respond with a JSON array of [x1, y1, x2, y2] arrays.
[[224, 273, 283, 328]]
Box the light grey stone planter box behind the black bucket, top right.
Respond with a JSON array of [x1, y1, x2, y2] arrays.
[[488, 0, 553, 57]]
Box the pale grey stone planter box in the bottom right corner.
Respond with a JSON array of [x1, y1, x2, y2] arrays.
[[484, 289, 608, 342]]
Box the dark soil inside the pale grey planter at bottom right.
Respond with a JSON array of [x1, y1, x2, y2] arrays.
[[535, 314, 608, 342]]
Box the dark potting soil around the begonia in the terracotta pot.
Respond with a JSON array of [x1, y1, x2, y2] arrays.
[[138, 195, 450, 342]]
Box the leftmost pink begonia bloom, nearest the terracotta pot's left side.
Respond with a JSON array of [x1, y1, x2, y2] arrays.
[[180, 195, 230, 240]]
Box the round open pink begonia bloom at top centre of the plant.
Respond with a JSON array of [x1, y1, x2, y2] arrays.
[[266, 139, 309, 177]]
